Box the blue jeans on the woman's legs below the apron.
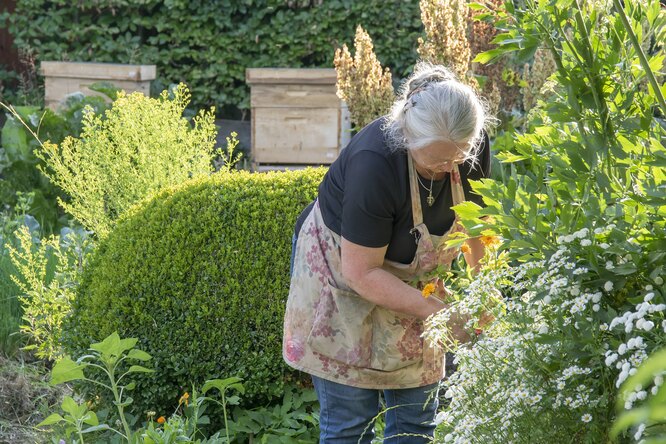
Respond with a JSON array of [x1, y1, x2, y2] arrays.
[[312, 376, 439, 444]]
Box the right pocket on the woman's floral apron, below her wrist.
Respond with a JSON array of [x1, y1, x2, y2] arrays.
[[370, 307, 423, 372]]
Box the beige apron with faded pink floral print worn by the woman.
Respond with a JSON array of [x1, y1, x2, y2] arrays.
[[282, 155, 465, 389]]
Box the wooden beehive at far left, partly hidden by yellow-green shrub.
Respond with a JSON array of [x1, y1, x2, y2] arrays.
[[40, 62, 157, 109]]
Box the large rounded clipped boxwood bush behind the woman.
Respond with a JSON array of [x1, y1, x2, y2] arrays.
[[66, 168, 325, 417]]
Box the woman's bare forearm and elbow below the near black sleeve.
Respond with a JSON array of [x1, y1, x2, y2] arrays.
[[341, 238, 445, 319]]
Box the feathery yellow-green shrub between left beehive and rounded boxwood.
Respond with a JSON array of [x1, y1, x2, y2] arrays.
[[37, 84, 217, 237]]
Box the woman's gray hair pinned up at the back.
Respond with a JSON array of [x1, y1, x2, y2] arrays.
[[383, 62, 491, 159]]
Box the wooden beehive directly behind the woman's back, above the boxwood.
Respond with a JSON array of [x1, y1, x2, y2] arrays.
[[245, 68, 351, 166]]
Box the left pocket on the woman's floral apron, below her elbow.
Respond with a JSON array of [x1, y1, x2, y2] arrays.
[[307, 283, 377, 368]]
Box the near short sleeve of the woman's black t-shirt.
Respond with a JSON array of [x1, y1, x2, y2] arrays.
[[341, 151, 399, 248]]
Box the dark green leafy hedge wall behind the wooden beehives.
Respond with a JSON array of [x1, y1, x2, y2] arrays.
[[0, 0, 421, 116]]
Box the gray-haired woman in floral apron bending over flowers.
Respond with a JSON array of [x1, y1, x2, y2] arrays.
[[283, 63, 490, 443]]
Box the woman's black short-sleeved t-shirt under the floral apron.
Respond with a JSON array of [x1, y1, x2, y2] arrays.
[[297, 119, 491, 264]]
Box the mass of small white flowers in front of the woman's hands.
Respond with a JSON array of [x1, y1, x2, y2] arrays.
[[426, 224, 666, 444]]
